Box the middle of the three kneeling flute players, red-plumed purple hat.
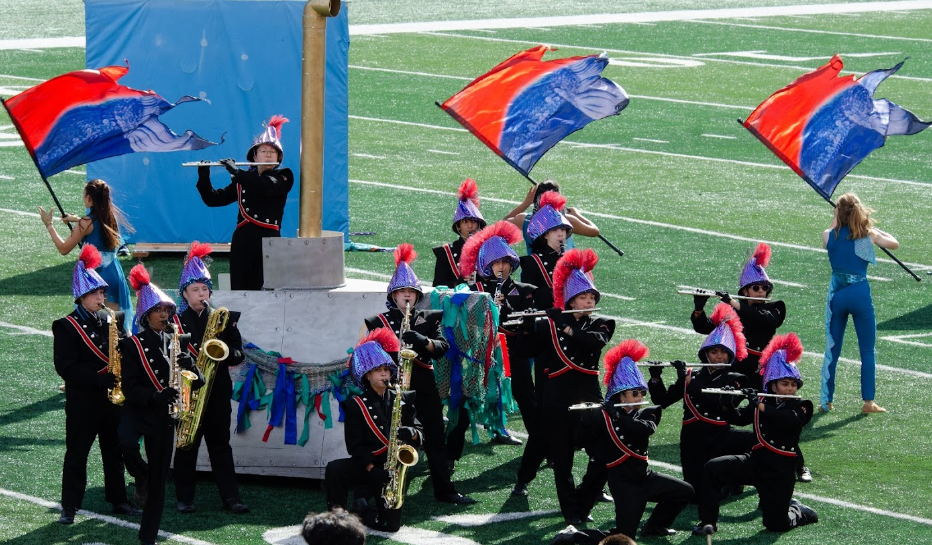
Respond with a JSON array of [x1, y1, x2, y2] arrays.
[[648, 303, 755, 496]]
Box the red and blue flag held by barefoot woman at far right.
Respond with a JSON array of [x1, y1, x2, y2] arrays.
[[742, 55, 932, 201]]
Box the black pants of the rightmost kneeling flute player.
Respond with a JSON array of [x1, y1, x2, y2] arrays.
[[699, 452, 803, 532]]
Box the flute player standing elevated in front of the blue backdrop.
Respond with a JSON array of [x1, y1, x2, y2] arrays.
[[197, 115, 294, 290]]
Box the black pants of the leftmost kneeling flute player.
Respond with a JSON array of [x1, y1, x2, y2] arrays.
[[608, 464, 694, 537]]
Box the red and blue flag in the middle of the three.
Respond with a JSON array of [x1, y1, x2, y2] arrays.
[[440, 45, 628, 176]]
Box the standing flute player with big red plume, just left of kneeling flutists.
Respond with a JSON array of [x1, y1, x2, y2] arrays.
[[512, 249, 615, 525]]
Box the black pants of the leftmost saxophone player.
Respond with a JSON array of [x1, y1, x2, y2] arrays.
[[61, 385, 126, 509]]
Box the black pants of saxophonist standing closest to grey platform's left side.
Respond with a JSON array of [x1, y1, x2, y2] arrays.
[[172, 392, 240, 503]]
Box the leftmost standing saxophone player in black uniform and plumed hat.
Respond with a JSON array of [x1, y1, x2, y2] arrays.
[[52, 244, 142, 524]]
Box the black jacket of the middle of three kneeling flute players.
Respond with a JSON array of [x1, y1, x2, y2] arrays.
[[647, 367, 745, 428]]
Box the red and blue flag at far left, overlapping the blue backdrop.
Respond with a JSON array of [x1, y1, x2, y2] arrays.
[[3, 66, 216, 177]]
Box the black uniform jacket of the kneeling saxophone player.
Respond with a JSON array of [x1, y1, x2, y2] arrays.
[[341, 385, 424, 467]]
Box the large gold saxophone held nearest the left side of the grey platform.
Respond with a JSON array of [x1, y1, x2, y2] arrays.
[[175, 301, 230, 449]]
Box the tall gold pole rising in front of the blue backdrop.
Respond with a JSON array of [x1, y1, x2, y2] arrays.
[[298, 0, 340, 238]]
